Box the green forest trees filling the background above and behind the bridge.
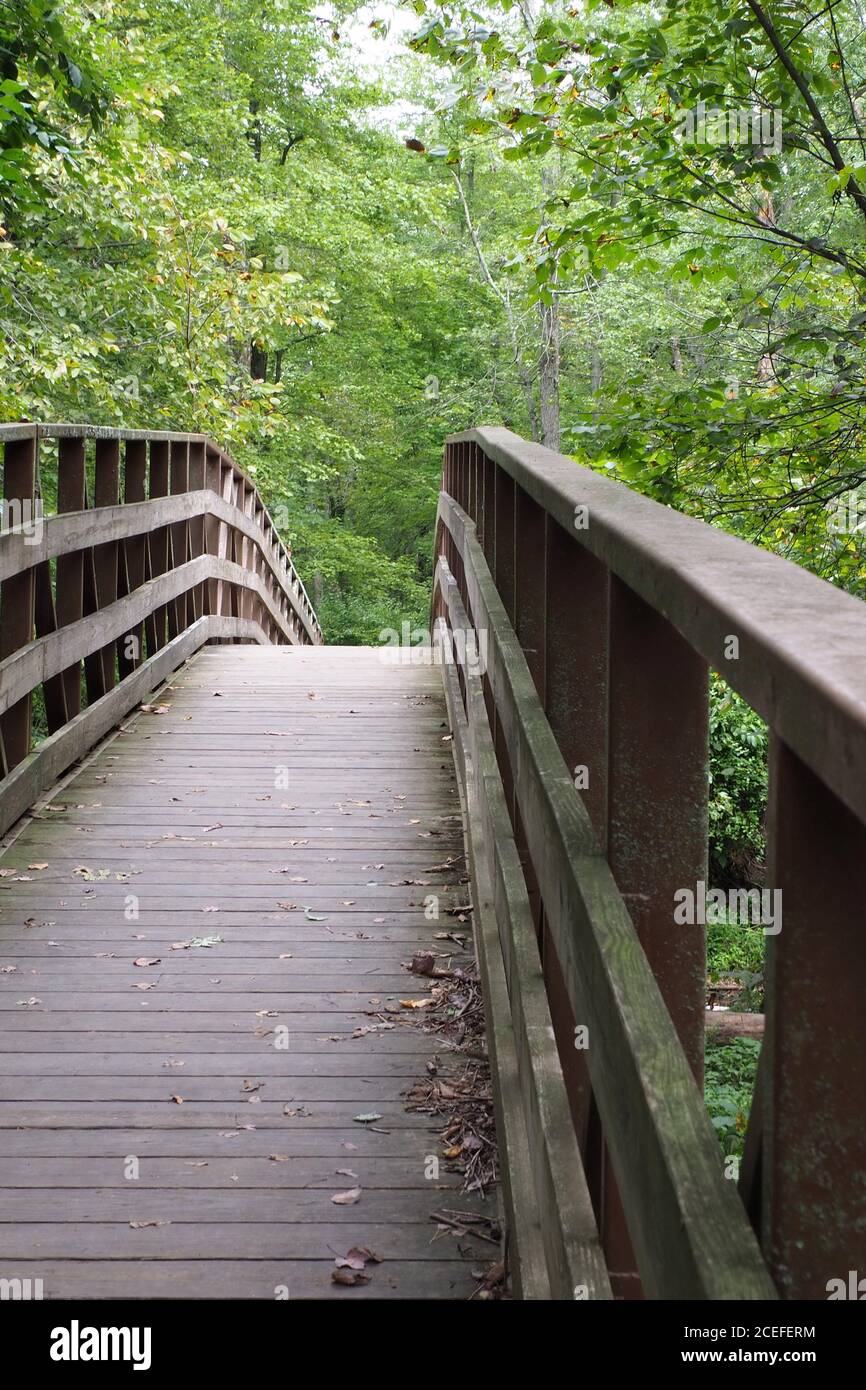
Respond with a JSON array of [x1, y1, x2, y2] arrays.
[[0, 0, 866, 641]]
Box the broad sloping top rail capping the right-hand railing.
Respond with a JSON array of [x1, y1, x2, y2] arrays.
[[448, 428, 866, 820]]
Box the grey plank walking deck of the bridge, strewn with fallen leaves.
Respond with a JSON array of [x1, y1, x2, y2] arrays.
[[0, 646, 496, 1298]]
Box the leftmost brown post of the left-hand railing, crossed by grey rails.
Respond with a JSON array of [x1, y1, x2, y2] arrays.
[[0, 432, 38, 770]]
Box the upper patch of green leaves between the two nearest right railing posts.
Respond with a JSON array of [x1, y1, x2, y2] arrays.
[[709, 674, 767, 885]]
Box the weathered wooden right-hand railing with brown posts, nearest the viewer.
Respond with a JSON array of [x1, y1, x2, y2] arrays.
[[434, 430, 866, 1298]]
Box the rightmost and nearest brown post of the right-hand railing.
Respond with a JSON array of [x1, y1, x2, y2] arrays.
[[762, 738, 866, 1300]]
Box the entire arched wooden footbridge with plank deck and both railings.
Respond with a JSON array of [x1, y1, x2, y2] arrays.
[[0, 425, 866, 1300]]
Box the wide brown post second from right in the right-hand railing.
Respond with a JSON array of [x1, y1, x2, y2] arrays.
[[603, 569, 709, 1295]]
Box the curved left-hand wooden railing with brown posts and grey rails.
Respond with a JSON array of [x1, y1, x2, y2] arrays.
[[0, 424, 321, 831]]
